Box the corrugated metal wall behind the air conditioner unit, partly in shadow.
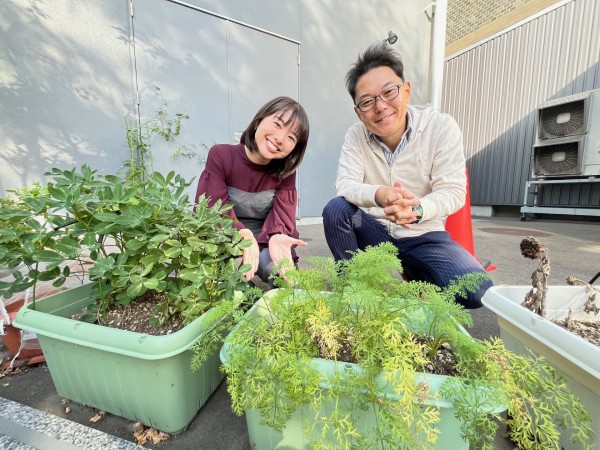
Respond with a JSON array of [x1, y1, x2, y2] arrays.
[[442, 0, 600, 207]]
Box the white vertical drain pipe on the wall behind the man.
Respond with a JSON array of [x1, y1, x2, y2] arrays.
[[425, 0, 448, 111]]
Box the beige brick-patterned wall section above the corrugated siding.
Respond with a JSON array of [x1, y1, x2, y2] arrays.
[[445, 0, 560, 57]]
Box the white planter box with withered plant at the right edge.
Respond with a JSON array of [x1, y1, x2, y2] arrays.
[[482, 286, 600, 450]]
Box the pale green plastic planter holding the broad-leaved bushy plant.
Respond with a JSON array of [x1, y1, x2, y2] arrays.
[[14, 284, 223, 434]]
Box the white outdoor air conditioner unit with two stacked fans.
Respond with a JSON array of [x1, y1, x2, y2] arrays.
[[532, 89, 600, 178]]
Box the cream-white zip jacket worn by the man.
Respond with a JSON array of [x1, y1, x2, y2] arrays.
[[335, 105, 466, 238]]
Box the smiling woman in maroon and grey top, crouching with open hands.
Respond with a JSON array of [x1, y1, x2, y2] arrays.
[[196, 97, 309, 286]]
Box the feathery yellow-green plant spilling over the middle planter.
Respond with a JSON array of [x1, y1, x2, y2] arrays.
[[222, 244, 593, 449]]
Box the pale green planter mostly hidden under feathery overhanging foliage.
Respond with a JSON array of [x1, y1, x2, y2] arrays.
[[221, 290, 505, 450]]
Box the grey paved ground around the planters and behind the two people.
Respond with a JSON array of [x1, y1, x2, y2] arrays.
[[0, 216, 600, 450]]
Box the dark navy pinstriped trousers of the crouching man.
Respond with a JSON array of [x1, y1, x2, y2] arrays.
[[323, 197, 492, 309]]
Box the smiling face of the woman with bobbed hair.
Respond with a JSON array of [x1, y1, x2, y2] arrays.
[[252, 111, 298, 164]]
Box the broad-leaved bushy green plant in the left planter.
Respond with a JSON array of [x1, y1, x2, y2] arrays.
[[0, 165, 248, 336]]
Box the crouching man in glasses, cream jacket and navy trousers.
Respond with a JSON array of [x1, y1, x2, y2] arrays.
[[323, 45, 492, 308]]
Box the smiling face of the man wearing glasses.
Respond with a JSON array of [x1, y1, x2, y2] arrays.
[[354, 66, 410, 150]]
